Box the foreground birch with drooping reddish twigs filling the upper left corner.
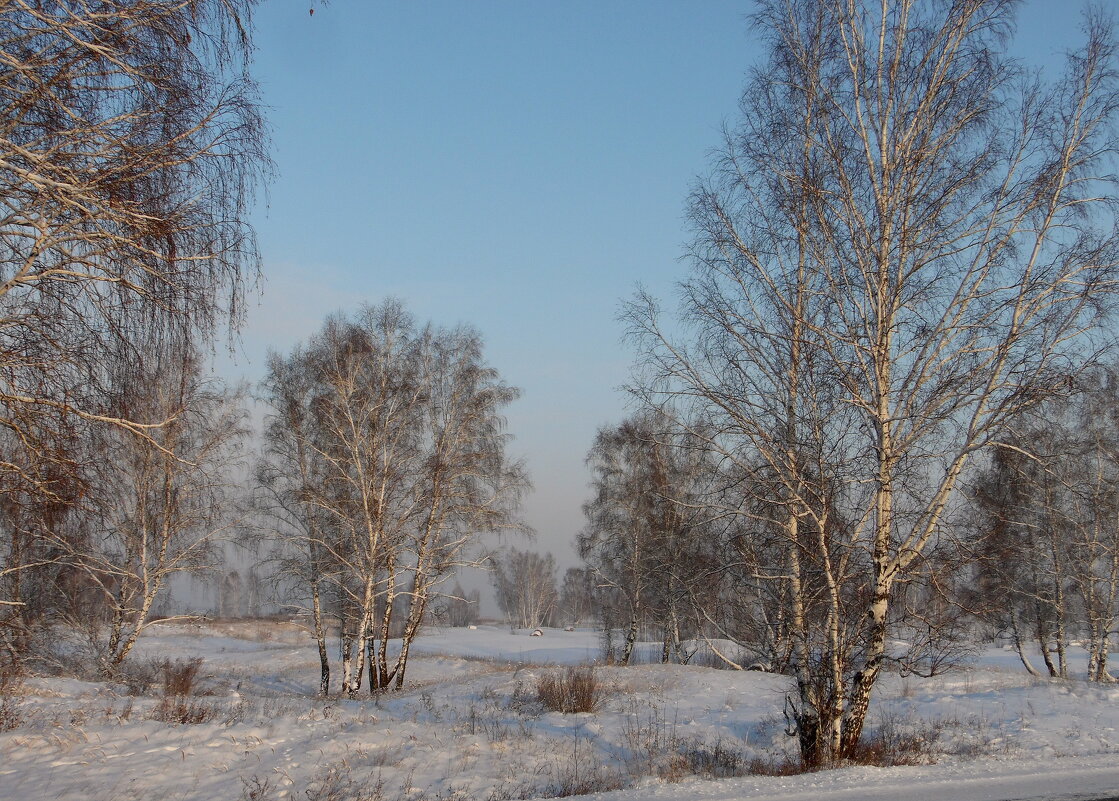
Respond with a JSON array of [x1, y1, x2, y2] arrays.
[[0, 0, 269, 653]]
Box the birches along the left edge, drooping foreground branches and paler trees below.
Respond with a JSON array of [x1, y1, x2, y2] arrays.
[[0, 0, 270, 672]]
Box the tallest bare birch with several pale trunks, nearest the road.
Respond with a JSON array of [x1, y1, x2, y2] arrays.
[[630, 0, 1117, 764]]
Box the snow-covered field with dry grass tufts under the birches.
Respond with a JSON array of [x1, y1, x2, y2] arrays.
[[0, 622, 1119, 801]]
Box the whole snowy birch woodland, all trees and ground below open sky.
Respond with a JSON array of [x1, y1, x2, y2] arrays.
[[0, 0, 1119, 801]]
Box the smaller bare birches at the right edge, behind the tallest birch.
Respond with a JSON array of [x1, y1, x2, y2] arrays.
[[974, 368, 1119, 681]]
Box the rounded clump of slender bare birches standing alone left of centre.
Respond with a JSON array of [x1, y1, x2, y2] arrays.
[[257, 302, 527, 695]]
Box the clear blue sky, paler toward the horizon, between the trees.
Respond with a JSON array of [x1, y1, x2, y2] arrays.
[[222, 0, 1080, 567]]
